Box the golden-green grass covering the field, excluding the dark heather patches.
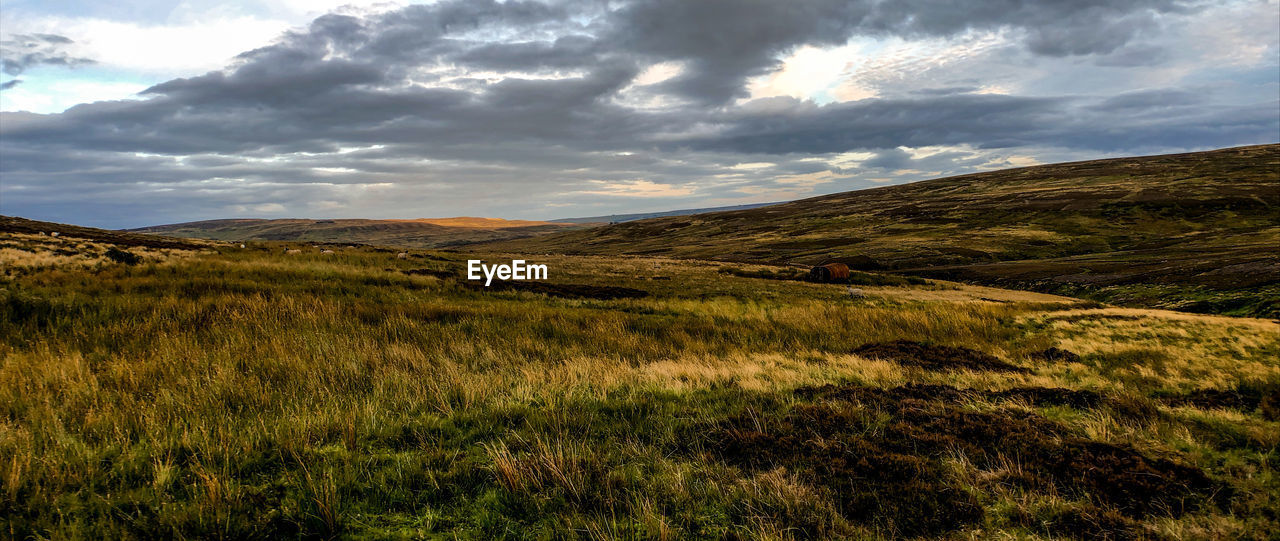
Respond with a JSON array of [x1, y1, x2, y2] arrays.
[[0, 231, 1280, 538]]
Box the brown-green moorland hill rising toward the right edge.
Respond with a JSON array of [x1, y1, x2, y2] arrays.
[[486, 145, 1280, 317]]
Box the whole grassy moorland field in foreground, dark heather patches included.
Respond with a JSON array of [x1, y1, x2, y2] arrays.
[[0, 225, 1280, 540]]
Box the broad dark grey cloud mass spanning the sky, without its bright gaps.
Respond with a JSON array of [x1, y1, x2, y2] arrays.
[[0, 0, 1280, 225]]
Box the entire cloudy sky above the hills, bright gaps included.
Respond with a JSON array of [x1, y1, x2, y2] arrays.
[[0, 0, 1280, 228]]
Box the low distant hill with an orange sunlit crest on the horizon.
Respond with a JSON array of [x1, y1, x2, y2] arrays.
[[128, 216, 582, 248]]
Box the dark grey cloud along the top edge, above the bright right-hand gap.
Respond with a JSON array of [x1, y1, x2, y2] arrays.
[[611, 0, 1192, 104]]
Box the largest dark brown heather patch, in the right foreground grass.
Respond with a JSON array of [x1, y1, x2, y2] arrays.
[[707, 385, 1230, 538]]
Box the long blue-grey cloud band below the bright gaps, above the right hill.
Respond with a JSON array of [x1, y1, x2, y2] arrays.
[[689, 90, 1280, 153]]
